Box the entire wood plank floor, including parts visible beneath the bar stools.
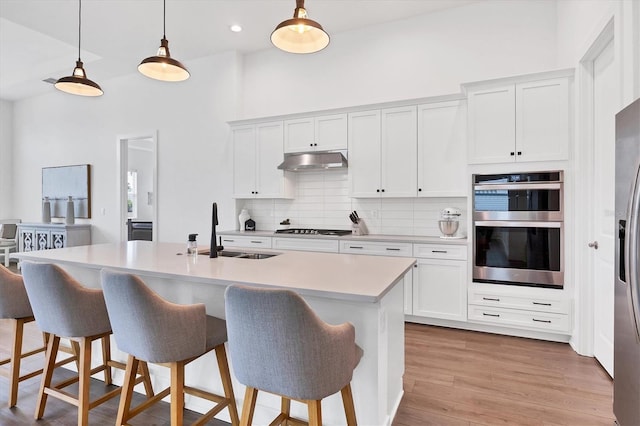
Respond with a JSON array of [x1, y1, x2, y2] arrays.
[[0, 262, 614, 426]]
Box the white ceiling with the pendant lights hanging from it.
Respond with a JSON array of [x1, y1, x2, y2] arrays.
[[0, 0, 479, 100]]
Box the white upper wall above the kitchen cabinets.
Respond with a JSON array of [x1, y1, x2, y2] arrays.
[[238, 0, 556, 118]]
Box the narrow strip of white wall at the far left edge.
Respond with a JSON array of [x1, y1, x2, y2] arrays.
[[0, 100, 14, 219]]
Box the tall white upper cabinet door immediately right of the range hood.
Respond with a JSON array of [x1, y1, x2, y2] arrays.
[[348, 110, 380, 197]]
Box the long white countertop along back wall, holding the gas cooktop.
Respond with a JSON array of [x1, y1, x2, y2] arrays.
[[217, 230, 469, 245]]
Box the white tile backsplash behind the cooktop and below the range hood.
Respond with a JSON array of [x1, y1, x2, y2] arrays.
[[236, 170, 467, 236]]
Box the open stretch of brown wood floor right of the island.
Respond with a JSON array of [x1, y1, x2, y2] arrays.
[[393, 324, 614, 426]]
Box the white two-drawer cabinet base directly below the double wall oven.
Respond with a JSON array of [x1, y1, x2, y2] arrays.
[[469, 283, 571, 335]]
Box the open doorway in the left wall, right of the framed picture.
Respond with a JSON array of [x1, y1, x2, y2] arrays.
[[118, 132, 158, 241]]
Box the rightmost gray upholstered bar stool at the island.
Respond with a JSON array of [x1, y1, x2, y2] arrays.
[[225, 285, 362, 426]]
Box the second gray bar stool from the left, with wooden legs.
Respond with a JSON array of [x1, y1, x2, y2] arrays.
[[22, 261, 153, 426]]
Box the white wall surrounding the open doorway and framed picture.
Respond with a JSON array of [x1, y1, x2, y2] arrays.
[[14, 53, 241, 243]]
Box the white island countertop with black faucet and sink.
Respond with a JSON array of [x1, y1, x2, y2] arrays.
[[15, 241, 415, 303]]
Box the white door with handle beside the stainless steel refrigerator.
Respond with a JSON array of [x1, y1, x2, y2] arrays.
[[581, 20, 620, 377]]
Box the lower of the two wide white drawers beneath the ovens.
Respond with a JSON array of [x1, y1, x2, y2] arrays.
[[468, 305, 570, 333]]
